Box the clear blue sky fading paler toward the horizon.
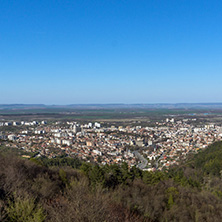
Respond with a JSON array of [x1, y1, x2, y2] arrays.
[[0, 0, 222, 104]]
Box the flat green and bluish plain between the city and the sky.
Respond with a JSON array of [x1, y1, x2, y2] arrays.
[[0, 105, 222, 124]]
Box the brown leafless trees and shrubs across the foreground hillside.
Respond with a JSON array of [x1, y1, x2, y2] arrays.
[[0, 155, 222, 222]]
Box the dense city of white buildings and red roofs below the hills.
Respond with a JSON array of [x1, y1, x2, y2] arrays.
[[0, 118, 222, 171]]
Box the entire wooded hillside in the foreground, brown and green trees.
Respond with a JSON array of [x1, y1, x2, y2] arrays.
[[0, 142, 222, 222]]
